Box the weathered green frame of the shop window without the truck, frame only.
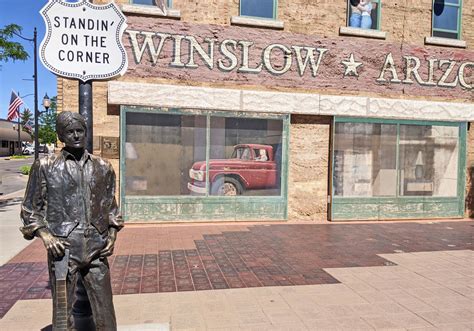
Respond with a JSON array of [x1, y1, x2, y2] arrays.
[[329, 116, 467, 221]]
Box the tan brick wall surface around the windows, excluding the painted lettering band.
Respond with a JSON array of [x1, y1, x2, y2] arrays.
[[54, 0, 474, 220]]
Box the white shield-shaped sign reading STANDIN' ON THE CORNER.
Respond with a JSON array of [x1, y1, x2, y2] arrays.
[[40, 0, 128, 81]]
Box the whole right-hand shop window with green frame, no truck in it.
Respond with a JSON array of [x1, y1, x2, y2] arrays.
[[331, 118, 466, 220]]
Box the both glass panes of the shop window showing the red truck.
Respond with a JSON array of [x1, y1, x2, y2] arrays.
[[124, 111, 283, 200]]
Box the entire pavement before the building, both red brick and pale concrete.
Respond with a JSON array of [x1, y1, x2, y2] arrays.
[[0, 214, 474, 330]]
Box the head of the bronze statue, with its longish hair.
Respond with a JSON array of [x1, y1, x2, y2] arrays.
[[56, 111, 87, 149]]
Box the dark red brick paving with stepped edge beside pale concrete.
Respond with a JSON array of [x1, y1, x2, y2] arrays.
[[0, 221, 474, 317]]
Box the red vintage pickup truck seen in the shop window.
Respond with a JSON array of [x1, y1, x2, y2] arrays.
[[188, 144, 277, 195]]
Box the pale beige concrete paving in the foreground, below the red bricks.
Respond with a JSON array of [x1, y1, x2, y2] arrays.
[[0, 250, 474, 330]]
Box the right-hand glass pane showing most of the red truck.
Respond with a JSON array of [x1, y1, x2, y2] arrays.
[[209, 117, 282, 195]]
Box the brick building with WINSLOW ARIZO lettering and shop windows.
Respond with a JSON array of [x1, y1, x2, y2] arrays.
[[58, 0, 474, 221]]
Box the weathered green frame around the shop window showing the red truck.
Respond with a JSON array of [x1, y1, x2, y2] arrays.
[[119, 105, 290, 221]]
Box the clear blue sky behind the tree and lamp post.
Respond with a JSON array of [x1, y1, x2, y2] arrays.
[[0, 0, 57, 119]]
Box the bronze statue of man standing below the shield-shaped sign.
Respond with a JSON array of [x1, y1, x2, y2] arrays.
[[20, 111, 123, 331]]
